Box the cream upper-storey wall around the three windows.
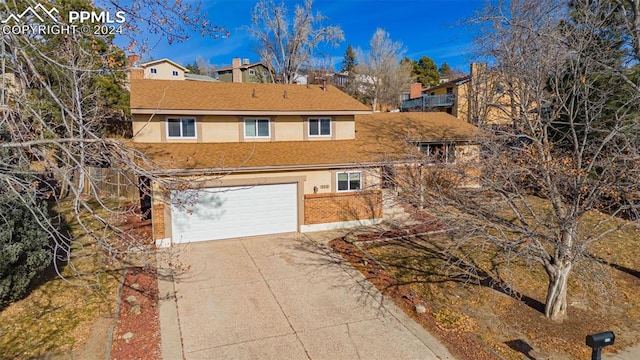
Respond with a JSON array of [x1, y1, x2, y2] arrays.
[[132, 114, 355, 143]]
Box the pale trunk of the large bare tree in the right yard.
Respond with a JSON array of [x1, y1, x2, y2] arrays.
[[544, 261, 572, 321]]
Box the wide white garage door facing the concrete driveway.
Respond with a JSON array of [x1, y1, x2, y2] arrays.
[[171, 183, 298, 243]]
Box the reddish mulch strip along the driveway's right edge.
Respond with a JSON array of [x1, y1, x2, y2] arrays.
[[329, 236, 500, 360]]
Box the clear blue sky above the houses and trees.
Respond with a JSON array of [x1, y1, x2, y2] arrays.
[[138, 0, 485, 72]]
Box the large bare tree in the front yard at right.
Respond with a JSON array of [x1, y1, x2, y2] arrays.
[[388, 0, 640, 320]]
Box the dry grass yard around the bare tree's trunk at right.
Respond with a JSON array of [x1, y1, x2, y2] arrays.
[[367, 198, 640, 359]]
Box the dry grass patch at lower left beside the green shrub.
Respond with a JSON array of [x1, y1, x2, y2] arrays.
[[0, 200, 127, 359]]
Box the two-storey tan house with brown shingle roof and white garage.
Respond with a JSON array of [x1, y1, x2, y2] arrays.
[[131, 79, 476, 245]]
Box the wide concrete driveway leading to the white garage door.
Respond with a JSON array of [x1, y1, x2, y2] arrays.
[[160, 232, 453, 360]]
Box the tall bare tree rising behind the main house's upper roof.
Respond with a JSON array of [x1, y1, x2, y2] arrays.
[[248, 0, 344, 84]]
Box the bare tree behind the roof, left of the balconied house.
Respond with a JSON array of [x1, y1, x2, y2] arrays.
[[355, 29, 411, 111]]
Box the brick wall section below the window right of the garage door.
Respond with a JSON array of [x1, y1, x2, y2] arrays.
[[304, 190, 382, 225]]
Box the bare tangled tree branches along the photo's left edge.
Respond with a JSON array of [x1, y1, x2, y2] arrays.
[[0, 0, 225, 282]]
